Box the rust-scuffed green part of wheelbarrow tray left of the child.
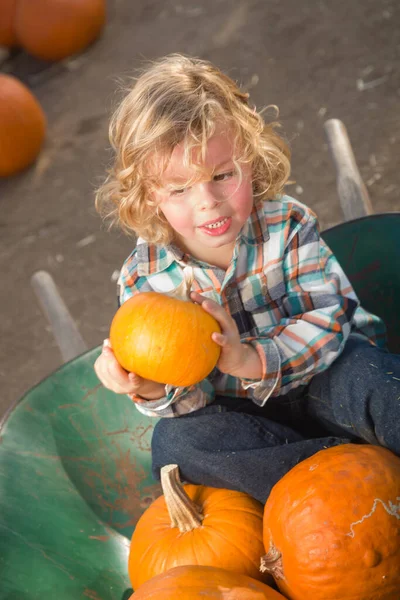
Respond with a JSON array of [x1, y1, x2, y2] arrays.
[[0, 348, 161, 600]]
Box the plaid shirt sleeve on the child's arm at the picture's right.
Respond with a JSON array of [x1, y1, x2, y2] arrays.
[[242, 212, 359, 406]]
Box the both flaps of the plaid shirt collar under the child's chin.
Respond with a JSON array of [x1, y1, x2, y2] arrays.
[[136, 202, 269, 276]]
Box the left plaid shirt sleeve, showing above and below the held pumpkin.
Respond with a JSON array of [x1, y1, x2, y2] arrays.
[[117, 251, 215, 417]]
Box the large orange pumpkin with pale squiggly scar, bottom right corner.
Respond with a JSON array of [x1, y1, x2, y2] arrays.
[[262, 444, 400, 600]]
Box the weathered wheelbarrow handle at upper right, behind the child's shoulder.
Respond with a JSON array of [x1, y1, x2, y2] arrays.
[[324, 119, 374, 221]]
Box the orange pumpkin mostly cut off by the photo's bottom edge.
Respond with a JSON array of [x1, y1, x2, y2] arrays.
[[129, 565, 286, 600]]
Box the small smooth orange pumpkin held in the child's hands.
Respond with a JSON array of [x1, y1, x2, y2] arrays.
[[110, 292, 220, 386]]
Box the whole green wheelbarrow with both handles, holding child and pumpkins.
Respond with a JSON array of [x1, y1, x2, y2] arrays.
[[0, 120, 400, 600]]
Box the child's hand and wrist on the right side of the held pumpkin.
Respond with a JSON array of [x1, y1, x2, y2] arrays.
[[190, 292, 262, 379]]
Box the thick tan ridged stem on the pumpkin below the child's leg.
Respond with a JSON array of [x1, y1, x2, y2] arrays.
[[161, 465, 204, 533]]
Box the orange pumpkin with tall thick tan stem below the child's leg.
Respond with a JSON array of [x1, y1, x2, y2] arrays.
[[128, 465, 269, 590]]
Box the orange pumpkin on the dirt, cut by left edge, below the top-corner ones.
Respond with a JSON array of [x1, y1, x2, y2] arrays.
[[0, 73, 46, 177]]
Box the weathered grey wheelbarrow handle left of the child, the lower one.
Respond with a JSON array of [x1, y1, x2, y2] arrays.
[[31, 271, 88, 362]]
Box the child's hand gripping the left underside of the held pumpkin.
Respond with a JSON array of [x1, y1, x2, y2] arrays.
[[94, 340, 165, 402]]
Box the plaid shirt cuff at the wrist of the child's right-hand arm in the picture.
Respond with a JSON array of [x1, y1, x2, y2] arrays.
[[240, 338, 281, 406]]
